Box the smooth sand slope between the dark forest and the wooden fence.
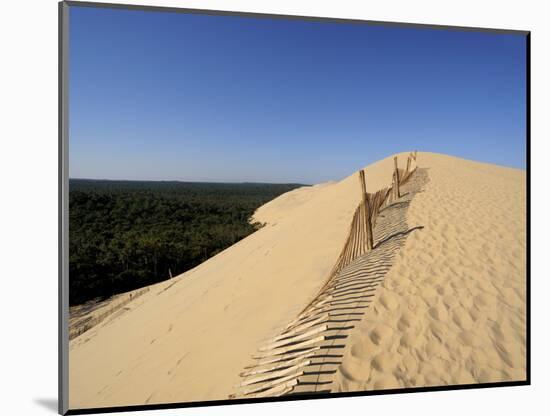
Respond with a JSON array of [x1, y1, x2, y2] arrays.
[[69, 154, 406, 409]]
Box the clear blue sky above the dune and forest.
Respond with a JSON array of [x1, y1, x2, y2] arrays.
[[69, 7, 526, 183]]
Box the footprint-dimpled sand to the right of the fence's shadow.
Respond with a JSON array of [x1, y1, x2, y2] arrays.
[[332, 158, 526, 392]]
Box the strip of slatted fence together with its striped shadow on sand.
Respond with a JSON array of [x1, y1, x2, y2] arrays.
[[230, 157, 427, 397]]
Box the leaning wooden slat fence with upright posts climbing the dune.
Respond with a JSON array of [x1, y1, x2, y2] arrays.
[[230, 151, 417, 398]]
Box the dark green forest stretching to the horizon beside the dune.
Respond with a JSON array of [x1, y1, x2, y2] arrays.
[[69, 179, 301, 305]]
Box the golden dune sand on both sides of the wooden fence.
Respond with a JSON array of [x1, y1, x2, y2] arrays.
[[69, 153, 526, 409]]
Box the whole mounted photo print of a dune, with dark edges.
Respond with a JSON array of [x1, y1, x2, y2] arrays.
[[59, 2, 530, 414]]
